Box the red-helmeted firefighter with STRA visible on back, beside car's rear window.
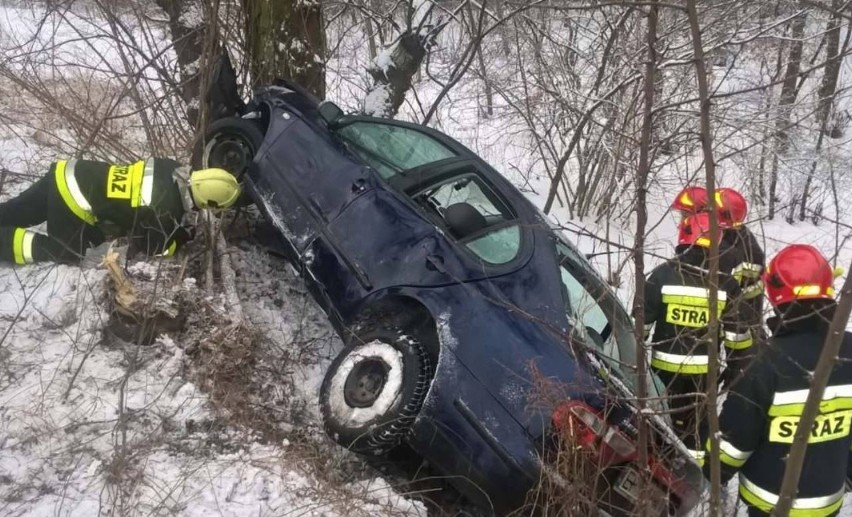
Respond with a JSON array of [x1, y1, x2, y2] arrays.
[[645, 212, 751, 462]]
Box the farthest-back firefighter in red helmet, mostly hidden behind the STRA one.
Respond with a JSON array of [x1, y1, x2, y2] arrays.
[[714, 188, 766, 380]]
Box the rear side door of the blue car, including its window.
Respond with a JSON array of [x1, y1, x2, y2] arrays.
[[306, 159, 531, 314]]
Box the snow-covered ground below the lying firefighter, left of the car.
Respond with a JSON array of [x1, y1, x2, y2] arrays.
[[0, 243, 425, 516]]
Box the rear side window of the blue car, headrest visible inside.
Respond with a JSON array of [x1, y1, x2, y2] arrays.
[[413, 173, 521, 264]]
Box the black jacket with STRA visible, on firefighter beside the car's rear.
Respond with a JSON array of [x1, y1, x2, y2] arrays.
[[645, 247, 752, 375]]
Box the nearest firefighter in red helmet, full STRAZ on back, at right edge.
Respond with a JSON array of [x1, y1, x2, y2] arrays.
[[704, 244, 852, 517]]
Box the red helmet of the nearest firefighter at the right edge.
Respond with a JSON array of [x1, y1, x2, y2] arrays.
[[763, 244, 834, 307]]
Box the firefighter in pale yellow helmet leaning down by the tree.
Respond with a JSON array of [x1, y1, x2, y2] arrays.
[[0, 158, 240, 264]]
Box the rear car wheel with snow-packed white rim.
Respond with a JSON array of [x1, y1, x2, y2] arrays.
[[320, 327, 432, 455]]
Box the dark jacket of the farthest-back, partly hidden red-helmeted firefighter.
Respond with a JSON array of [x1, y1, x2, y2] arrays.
[[720, 226, 766, 330]]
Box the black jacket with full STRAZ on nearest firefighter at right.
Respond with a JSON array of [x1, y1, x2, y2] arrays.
[[705, 313, 852, 517]]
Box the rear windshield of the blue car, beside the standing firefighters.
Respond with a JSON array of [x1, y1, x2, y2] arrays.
[[556, 242, 659, 406]]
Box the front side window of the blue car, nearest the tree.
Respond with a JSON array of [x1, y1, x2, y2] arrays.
[[338, 122, 457, 179]]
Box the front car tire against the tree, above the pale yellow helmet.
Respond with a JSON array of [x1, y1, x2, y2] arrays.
[[193, 117, 263, 206]]
